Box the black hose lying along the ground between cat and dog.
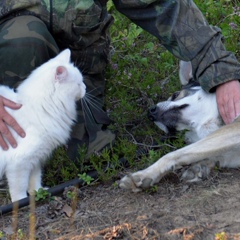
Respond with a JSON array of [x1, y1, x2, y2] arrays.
[[0, 158, 128, 215]]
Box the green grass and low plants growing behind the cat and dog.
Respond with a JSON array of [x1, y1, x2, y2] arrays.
[[40, 0, 240, 186]]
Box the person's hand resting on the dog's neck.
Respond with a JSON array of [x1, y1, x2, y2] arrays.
[[216, 80, 240, 124]]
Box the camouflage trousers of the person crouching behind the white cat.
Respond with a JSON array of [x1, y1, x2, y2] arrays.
[[0, 15, 115, 158]]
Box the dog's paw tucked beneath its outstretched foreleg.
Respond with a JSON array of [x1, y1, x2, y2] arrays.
[[181, 164, 211, 182]]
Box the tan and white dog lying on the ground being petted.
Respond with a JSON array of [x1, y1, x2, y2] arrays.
[[119, 62, 240, 192]]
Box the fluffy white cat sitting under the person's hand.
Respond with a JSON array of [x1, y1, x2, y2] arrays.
[[0, 49, 86, 202]]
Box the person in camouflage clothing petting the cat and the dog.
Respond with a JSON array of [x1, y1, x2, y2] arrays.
[[0, 0, 240, 160]]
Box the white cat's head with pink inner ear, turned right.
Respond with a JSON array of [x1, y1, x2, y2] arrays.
[[18, 49, 86, 101]]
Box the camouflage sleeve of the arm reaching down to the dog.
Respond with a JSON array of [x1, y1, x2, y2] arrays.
[[113, 0, 240, 91]]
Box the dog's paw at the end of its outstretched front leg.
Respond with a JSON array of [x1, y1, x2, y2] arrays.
[[119, 172, 155, 192]]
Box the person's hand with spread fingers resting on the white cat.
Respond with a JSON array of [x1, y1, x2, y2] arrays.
[[0, 96, 25, 150]]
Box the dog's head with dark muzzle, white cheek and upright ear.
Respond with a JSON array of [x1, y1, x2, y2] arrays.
[[148, 61, 223, 142]]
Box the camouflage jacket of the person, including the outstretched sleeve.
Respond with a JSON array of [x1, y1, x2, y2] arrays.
[[0, 0, 240, 91]]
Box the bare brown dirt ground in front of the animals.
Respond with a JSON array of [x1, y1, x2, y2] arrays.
[[0, 167, 240, 240]]
